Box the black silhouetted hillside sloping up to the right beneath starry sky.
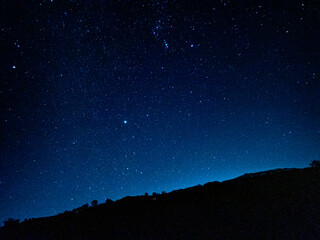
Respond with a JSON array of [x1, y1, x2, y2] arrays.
[[0, 168, 320, 240]]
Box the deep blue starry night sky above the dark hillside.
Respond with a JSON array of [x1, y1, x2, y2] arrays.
[[0, 0, 320, 222]]
